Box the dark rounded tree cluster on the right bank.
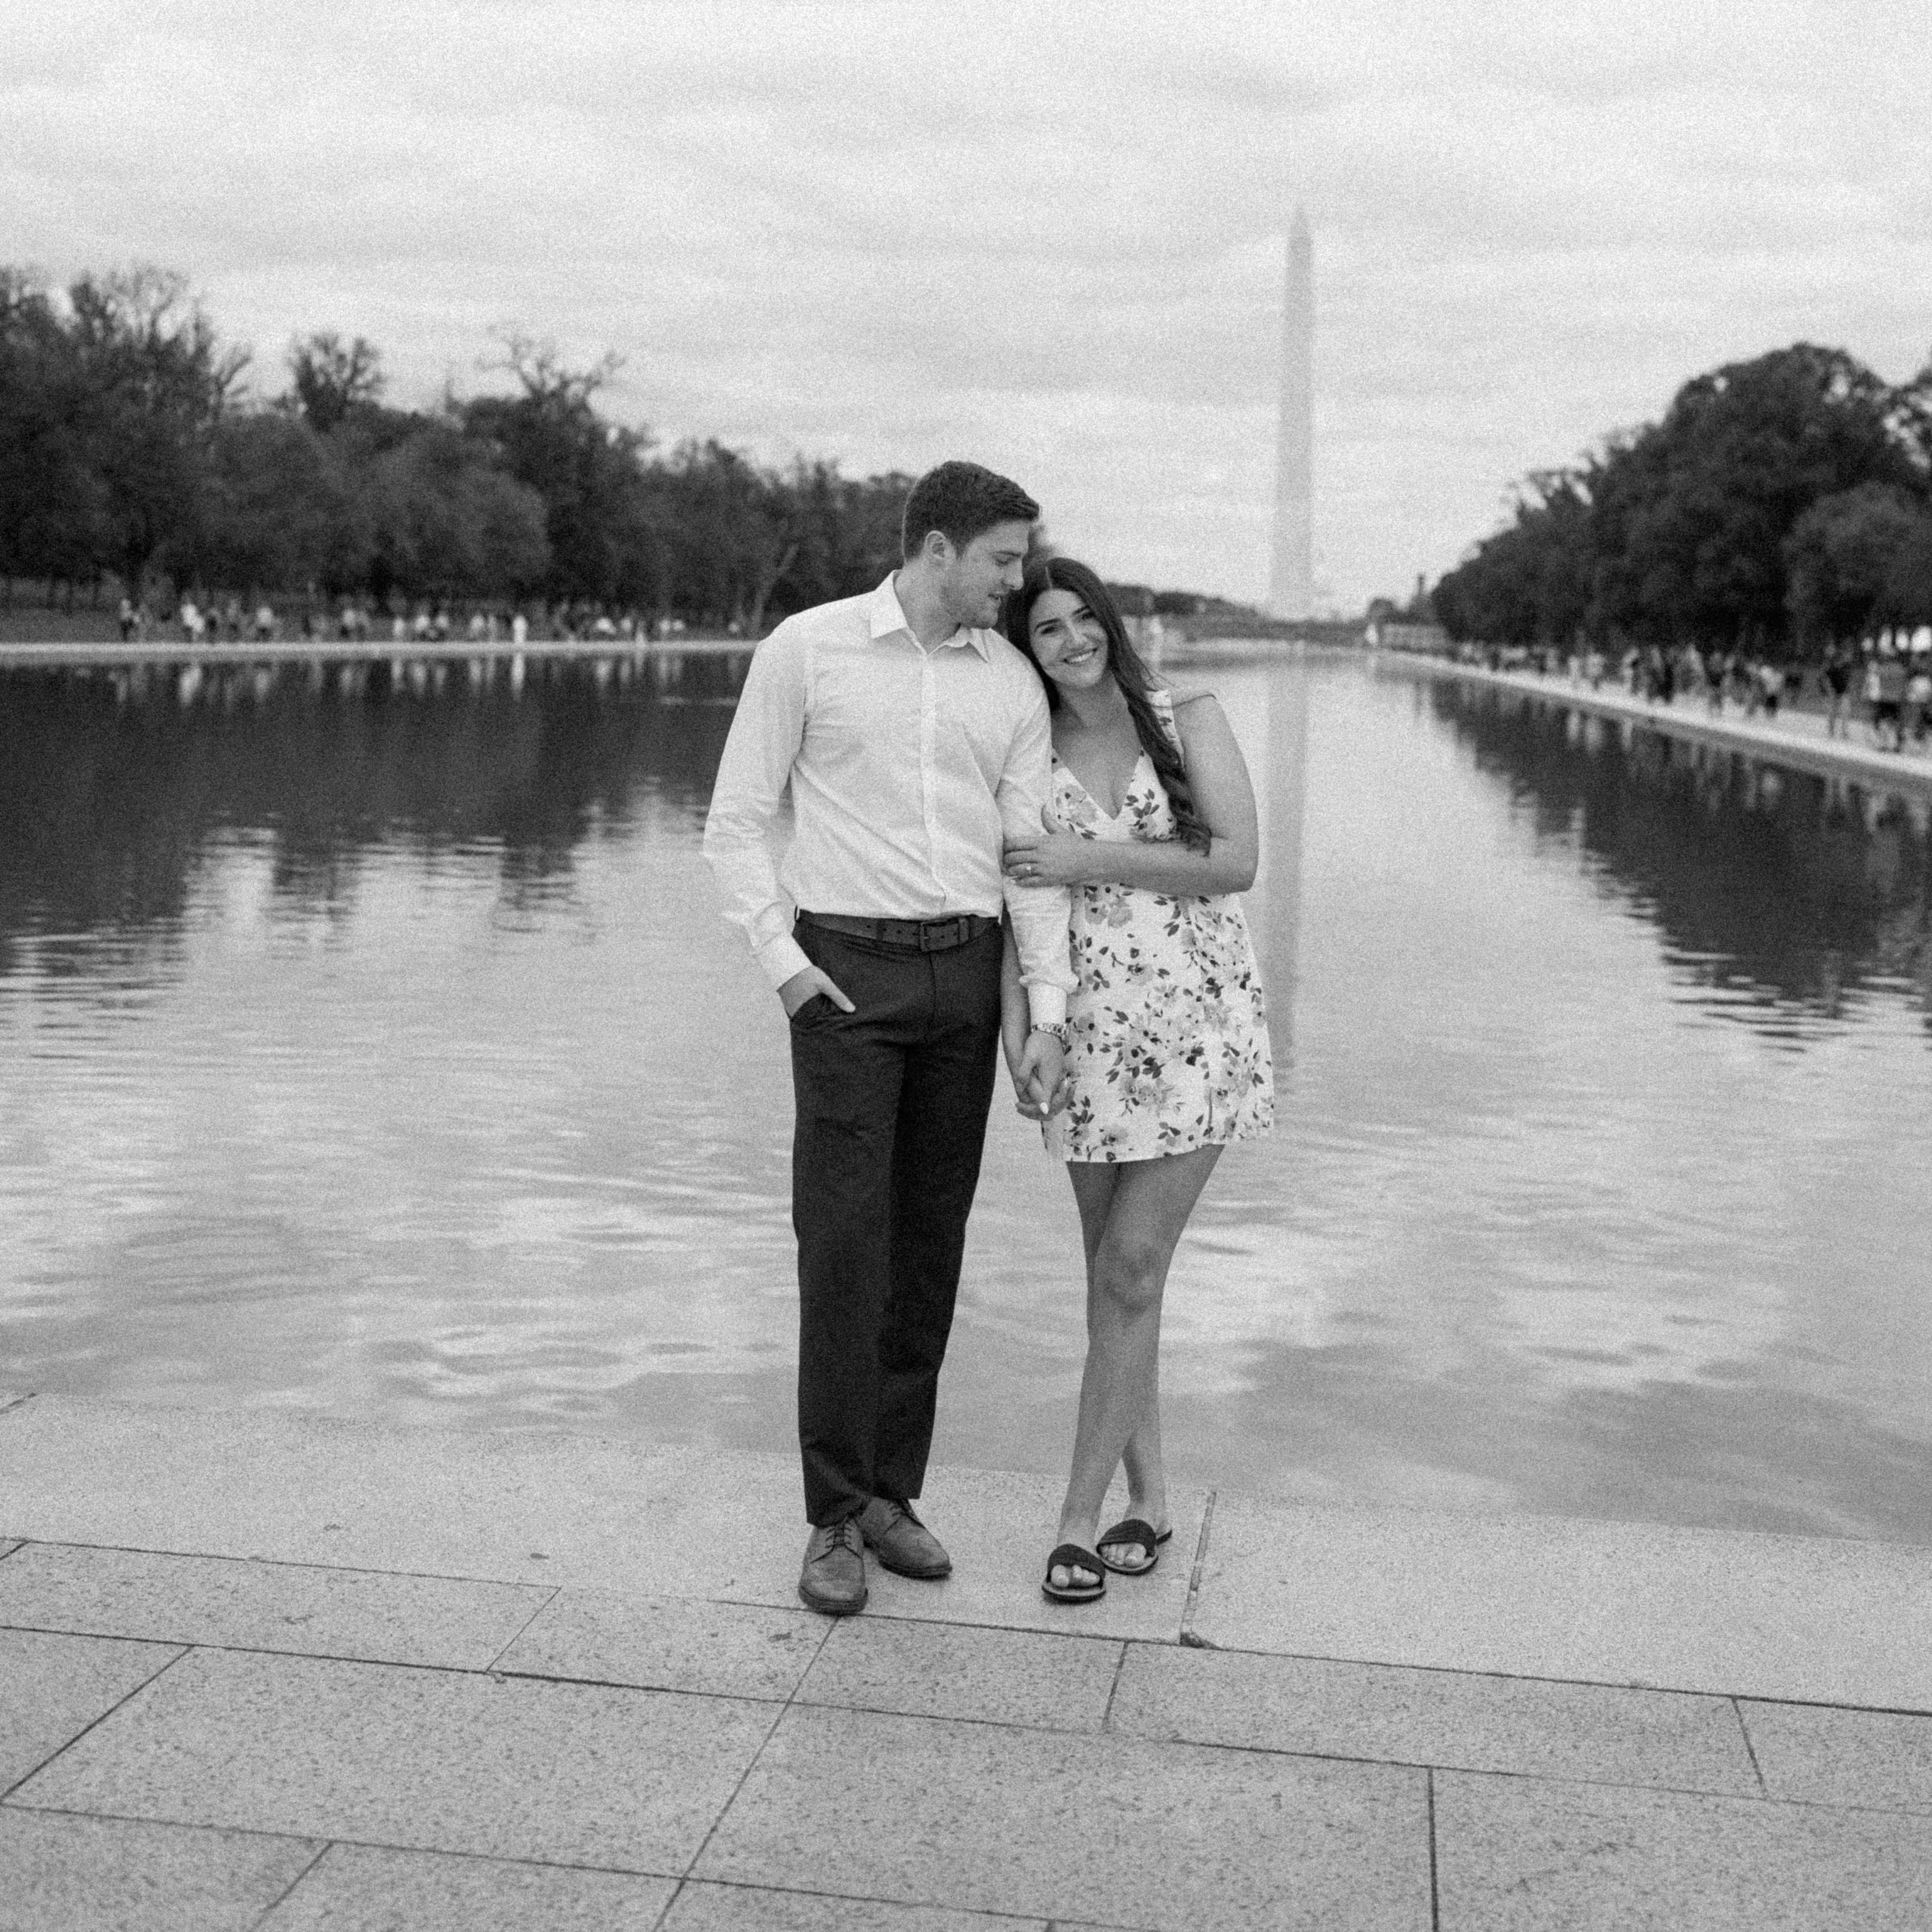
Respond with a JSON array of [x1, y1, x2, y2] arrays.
[[1432, 342, 1932, 655]]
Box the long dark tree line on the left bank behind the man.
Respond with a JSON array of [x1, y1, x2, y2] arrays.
[[0, 269, 927, 636]]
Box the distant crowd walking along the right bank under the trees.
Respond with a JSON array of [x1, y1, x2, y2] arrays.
[[1459, 624, 1932, 752]]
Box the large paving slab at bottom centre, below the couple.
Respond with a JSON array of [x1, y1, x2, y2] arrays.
[[693, 1704, 1430, 1932]]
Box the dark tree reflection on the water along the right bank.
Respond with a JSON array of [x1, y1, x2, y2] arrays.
[[1416, 678, 1932, 1045]]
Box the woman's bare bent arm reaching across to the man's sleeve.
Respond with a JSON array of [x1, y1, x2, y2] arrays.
[[1006, 692, 1262, 898]]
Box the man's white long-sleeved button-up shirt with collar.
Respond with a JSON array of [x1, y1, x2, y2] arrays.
[[705, 578, 1074, 1024]]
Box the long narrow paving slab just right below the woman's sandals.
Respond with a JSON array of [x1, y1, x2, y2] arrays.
[[1109, 1644, 1762, 1797]]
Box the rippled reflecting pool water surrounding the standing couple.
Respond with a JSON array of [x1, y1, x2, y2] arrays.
[[0, 659, 1932, 1542]]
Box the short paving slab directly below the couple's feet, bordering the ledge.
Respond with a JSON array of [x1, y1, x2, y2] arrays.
[[798, 1617, 1142, 1731]]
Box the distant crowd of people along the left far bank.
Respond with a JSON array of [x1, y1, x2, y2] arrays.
[[118, 597, 718, 649]]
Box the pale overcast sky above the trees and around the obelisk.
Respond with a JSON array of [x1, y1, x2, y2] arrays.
[[0, 0, 1932, 609]]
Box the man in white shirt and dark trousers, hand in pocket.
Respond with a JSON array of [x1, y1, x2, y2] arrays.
[[705, 462, 1072, 1617]]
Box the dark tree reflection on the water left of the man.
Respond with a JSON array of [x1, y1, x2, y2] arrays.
[[0, 655, 746, 974]]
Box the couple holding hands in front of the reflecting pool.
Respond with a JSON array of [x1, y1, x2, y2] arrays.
[[705, 462, 1273, 1615]]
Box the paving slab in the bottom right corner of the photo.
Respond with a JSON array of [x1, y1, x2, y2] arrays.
[[1436, 1772, 1932, 1932]]
